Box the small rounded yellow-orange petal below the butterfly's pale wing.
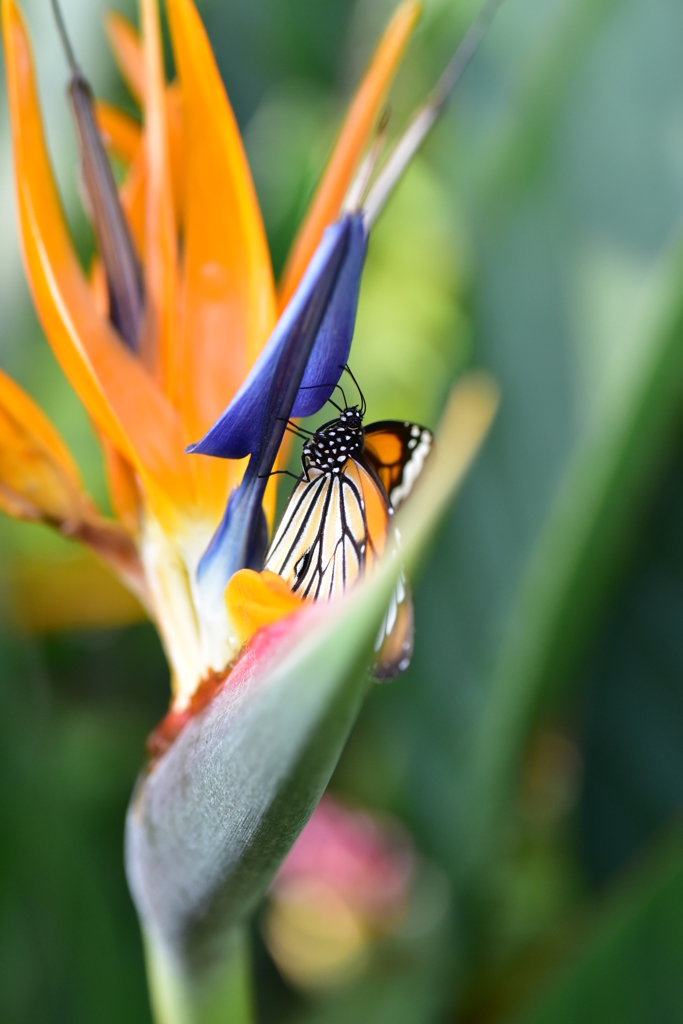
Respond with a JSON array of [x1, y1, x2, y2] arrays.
[[225, 569, 304, 643]]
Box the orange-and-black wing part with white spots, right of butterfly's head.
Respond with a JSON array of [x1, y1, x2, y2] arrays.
[[362, 420, 433, 509]]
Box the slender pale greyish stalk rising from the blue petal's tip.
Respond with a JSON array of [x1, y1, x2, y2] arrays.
[[364, 0, 503, 228]]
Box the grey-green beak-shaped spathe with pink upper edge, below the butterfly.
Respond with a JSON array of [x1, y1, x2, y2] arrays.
[[126, 375, 497, 1024]]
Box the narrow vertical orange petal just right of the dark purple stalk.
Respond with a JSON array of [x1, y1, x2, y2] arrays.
[[140, 0, 178, 391]]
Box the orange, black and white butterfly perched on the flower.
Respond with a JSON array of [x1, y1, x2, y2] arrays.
[[264, 387, 432, 679]]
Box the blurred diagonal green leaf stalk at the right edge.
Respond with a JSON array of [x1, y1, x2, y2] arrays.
[[468, 237, 683, 866]]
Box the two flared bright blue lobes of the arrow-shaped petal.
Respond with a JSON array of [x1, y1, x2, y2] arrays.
[[186, 214, 367, 459]]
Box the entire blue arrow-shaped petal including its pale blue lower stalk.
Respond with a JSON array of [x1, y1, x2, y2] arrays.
[[194, 216, 366, 603]]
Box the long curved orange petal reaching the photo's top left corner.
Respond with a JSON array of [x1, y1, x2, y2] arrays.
[[2, 0, 193, 522]]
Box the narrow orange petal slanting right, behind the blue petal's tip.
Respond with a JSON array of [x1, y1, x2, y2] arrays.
[[278, 0, 422, 309]]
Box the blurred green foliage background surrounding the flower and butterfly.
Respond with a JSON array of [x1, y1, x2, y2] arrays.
[[0, 0, 683, 1024]]
